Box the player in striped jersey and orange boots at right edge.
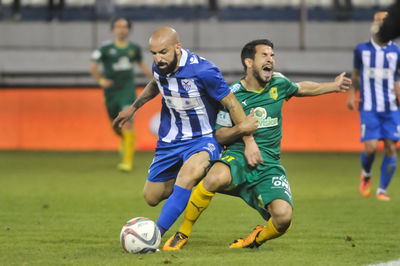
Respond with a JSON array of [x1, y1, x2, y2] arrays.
[[347, 11, 400, 201]]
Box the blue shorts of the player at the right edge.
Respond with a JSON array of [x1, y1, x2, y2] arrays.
[[360, 111, 400, 142]]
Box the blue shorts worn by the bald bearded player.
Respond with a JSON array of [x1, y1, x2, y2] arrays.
[[147, 137, 222, 182]]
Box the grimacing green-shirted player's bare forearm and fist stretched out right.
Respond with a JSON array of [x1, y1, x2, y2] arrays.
[[296, 72, 351, 97]]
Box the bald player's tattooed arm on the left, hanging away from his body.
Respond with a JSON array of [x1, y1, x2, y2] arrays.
[[113, 79, 160, 135]]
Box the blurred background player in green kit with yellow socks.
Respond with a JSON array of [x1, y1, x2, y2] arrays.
[[90, 18, 153, 171]]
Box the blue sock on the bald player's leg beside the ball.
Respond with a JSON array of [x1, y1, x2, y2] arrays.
[[157, 185, 192, 235]]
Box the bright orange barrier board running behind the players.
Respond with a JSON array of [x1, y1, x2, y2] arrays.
[[0, 88, 382, 151]]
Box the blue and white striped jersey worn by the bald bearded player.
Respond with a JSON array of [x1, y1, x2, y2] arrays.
[[153, 49, 230, 143]]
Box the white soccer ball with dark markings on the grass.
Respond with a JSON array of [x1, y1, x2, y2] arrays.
[[120, 217, 161, 253]]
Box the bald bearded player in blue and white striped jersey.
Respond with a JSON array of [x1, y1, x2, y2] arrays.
[[113, 27, 262, 238]]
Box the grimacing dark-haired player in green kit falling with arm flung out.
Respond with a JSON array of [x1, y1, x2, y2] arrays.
[[163, 39, 351, 250]]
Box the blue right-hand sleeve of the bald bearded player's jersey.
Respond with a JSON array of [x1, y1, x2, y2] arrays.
[[199, 66, 231, 101]]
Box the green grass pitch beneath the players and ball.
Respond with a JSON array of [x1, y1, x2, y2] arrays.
[[0, 151, 400, 265]]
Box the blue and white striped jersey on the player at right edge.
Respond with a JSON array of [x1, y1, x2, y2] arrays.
[[354, 39, 400, 112]]
